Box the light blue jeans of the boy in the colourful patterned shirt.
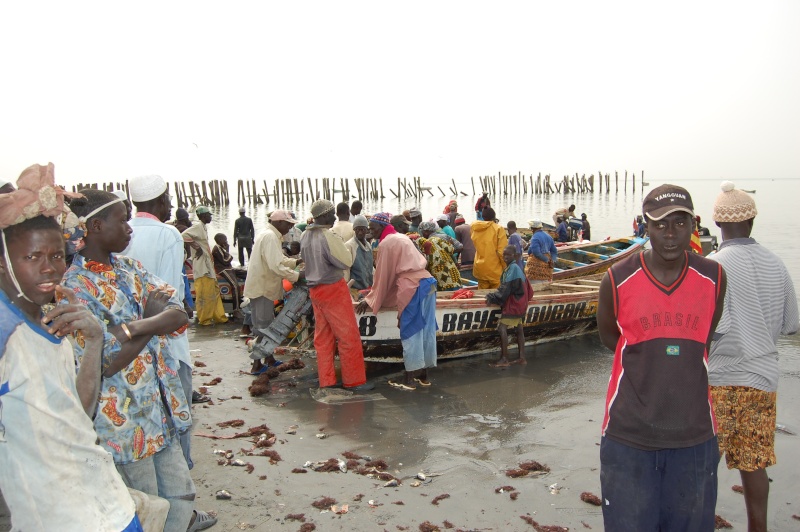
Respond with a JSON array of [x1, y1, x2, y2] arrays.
[[117, 440, 195, 532]]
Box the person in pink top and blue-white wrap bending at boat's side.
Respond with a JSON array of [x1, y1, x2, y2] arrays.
[[356, 212, 437, 390]]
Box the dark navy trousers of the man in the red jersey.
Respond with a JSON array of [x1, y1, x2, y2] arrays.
[[600, 436, 719, 532]]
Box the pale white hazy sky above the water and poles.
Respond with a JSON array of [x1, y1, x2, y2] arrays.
[[0, 0, 800, 184]]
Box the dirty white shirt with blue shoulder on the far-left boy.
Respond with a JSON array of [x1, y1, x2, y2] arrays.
[[0, 298, 136, 532]]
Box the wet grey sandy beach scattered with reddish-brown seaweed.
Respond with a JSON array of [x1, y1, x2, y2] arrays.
[[0, 325, 800, 531]]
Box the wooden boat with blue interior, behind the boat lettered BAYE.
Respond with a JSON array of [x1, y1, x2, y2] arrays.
[[460, 237, 649, 282]]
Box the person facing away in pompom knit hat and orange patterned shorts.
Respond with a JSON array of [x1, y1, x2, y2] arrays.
[[708, 181, 798, 531]]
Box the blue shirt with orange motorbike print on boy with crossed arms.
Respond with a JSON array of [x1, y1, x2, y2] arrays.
[[63, 255, 192, 464]]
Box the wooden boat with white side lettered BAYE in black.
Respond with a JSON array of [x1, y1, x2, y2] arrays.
[[356, 274, 602, 362]]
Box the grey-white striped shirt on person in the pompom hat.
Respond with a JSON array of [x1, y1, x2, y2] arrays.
[[709, 238, 799, 392]]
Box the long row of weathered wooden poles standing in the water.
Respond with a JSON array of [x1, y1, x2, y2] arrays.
[[72, 171, 647, 208]]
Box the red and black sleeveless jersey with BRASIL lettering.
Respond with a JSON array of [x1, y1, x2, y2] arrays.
[[603, 253, 721, 450]]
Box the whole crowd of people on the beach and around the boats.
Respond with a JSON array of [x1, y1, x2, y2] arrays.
[[0, 164, 799, 532]]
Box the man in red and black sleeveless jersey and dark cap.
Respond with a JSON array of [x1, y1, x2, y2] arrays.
[[597, 185, 725, 531]]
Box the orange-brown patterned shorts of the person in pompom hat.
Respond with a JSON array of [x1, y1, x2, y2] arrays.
[[711, 386, 777, 471]]
